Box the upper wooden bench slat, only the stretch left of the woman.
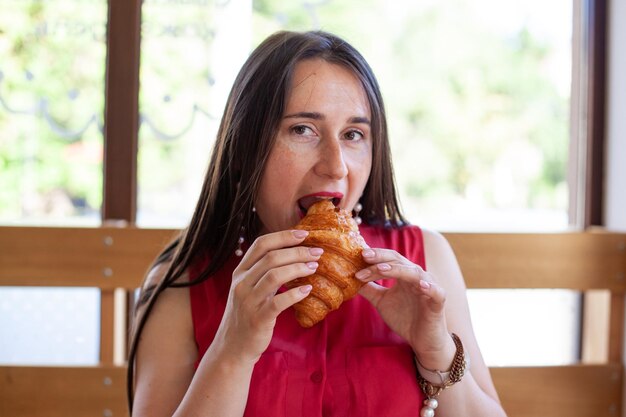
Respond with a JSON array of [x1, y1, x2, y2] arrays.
[[0, 227, 175, 289]]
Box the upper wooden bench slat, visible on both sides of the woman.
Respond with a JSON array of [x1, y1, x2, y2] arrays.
[[0, 227, 626, 293]]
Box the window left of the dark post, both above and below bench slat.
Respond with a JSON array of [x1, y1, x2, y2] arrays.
[[0, 0, 107, 364]]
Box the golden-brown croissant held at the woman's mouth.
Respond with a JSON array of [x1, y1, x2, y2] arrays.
[[286, 200, 368, 327]]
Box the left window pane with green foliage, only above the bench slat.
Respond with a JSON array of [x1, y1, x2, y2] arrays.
[[0, 0, 107, 225]]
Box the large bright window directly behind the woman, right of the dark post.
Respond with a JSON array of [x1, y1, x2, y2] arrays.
[[138, 0, 580, 364]]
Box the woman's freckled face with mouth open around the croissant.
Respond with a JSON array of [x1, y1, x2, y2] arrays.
[[255, 59, 372, 233]]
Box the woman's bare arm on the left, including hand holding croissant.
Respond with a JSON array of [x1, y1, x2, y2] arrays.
[[133, 231, 319, 417]]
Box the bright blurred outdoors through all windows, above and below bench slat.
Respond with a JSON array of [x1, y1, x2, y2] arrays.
[[0, 0, 620, 365]]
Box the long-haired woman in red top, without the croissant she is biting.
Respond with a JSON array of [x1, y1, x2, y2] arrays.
[[129, 32, 505, 417]]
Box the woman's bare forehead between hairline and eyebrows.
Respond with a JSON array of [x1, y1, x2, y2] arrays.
[[287, 59, 370, 116]]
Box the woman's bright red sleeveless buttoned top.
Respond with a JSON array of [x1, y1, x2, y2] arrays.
[[190, 225, 426, 417]]
